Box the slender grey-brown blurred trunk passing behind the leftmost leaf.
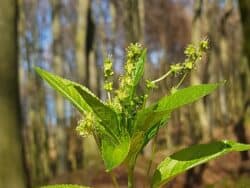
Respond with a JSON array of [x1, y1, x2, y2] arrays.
[[51, 0, 67, 174]]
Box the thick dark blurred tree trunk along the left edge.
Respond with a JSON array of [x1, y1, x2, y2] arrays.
[[0, 0, 26, 188]]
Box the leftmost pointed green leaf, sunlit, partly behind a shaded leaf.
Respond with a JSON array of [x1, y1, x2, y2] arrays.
[[35, 67, 90, 112]]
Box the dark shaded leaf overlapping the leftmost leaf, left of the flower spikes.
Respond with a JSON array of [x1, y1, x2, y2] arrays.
[[74, 85, 119, 134]]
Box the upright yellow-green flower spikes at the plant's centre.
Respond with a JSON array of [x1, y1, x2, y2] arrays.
[[101, 43, 147, 125]]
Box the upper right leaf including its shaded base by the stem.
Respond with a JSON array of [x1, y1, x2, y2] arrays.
[[132, 84, 220, 152]]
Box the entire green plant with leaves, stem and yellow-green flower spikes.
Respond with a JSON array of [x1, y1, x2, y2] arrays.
[[36, 40, 250, 188]]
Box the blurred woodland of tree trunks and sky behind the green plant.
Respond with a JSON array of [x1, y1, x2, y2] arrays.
[[0, 0, 250, 188]]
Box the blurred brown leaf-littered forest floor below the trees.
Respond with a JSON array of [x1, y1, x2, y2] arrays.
[[49, 124, 250, 188]]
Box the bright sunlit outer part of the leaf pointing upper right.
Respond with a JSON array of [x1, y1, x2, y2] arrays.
[[157, 83, 221, 111]]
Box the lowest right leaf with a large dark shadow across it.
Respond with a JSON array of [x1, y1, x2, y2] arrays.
[[151, 140, 250, 188]]
